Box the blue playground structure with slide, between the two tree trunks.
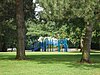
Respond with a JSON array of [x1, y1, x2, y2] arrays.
[[30, 38, 68, 52]]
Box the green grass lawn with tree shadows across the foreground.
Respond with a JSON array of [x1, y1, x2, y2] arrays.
[[0, 52, 100, 75]]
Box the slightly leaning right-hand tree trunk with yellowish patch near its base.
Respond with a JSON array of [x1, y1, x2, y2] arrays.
[[80, 24, 93, 63]]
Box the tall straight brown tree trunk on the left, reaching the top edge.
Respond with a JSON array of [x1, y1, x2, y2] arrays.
[[16, 0, 25, 60]]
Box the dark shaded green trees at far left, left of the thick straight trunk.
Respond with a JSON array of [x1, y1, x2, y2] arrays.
[[0, 0, 16, 52]]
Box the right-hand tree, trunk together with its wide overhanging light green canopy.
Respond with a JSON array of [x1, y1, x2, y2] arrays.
[[37, 0, 100, 63]]
